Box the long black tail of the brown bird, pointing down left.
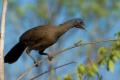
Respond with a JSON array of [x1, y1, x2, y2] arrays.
[[4, 42, 26, 64]]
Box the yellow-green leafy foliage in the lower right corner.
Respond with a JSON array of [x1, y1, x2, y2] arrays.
[[59, 32, 120, 80]]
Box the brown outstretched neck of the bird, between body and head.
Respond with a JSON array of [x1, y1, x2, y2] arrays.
[[57, 22, 73, 36]]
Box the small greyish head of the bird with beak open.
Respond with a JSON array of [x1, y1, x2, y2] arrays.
[[73, 19, 85, 30]]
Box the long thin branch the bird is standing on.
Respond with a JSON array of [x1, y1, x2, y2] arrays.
[[19, 39, 119, 80]]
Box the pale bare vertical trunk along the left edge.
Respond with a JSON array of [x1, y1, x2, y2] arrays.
[[0, 0, 7, 80]]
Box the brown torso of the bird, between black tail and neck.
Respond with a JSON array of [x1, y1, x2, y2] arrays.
[[20, 25, 57, 46]]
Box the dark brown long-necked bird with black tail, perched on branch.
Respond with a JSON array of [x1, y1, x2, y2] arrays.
[[4, 19, 85, 64]]
